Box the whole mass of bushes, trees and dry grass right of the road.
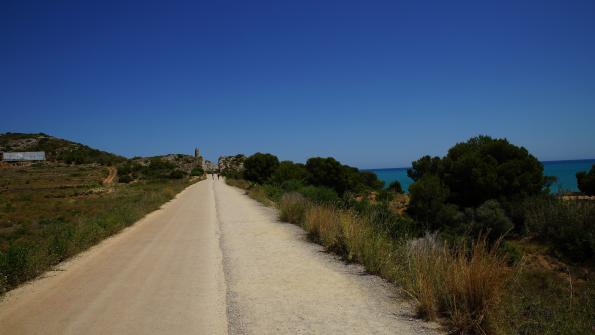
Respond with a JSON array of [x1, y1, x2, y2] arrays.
[[224, 136, 595, 334]]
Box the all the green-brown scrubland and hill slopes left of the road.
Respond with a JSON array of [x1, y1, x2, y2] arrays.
[[0, 133, 203, 295]]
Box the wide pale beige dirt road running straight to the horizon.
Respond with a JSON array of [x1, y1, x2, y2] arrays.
[[0, 178, 435, 335]]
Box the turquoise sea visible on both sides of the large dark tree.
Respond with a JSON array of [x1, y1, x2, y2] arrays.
[[369, 159, 595, 192]]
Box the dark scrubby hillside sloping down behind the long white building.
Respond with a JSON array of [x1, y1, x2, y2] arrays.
[[0, 133, 126, 165]]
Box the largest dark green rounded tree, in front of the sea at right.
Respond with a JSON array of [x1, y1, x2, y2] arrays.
[[407, 136, 546, 207]]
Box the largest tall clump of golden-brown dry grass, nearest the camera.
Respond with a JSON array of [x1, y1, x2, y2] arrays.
[[403, 235, 512, 334]]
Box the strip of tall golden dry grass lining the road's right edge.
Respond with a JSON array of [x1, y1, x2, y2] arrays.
[[279, 194, 511, 334]]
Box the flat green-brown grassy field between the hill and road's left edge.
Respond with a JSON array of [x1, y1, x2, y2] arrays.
[[0, 163, 190, 294]]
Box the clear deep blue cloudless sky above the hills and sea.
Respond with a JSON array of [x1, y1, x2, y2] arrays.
[[0, 0, 595, 168]]
